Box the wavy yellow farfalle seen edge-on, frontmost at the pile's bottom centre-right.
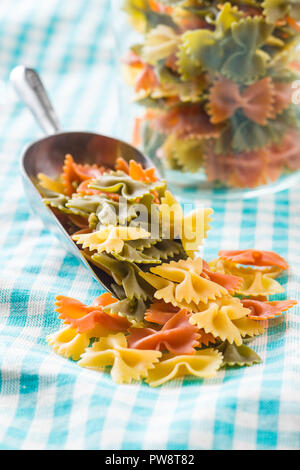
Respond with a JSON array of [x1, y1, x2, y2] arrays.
[[146, 348, 222, 387]]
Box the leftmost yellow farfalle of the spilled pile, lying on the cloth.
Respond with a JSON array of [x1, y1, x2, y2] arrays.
[[47, 326, 90, 361]]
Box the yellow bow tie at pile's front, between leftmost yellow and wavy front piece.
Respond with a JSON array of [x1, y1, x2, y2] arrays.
[[78, 333, 161, 383]]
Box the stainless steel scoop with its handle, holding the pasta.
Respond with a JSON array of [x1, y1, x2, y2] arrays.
[[10, 66, 159, 295]]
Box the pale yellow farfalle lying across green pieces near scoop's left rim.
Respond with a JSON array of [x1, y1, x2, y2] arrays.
[[72, 225, 150, 253]]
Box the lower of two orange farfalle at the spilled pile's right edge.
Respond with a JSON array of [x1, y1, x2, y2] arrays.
[[242, 299, 297, 320]]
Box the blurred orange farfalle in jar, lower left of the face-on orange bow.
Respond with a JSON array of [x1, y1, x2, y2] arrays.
[[152, 104, 220, 139]]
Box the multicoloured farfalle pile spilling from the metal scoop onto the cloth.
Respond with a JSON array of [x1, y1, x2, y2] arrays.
[[39, 155, 296, 387]]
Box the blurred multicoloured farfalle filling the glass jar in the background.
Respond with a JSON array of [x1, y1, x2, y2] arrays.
[[124, 0, 300, 187]]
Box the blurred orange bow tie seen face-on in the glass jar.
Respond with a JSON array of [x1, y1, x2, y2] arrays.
[[208, 77, 273, 126]]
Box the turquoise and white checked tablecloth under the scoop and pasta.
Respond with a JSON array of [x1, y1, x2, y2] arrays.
[[0, 0, 300, 450]]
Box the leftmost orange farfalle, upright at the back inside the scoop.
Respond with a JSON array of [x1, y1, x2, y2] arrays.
[[62, 154, 104, 196]]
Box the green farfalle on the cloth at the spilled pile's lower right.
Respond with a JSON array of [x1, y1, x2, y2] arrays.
[[217, 341, 261, 366]]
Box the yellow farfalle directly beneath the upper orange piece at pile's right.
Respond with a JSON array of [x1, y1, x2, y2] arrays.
[[209, 259, 284, 297]]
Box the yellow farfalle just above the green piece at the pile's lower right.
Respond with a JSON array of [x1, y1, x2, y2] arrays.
[[190, 296, 250, 345]]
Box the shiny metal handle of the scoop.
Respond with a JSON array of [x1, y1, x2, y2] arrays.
[[10, 65, 61, 135]]
